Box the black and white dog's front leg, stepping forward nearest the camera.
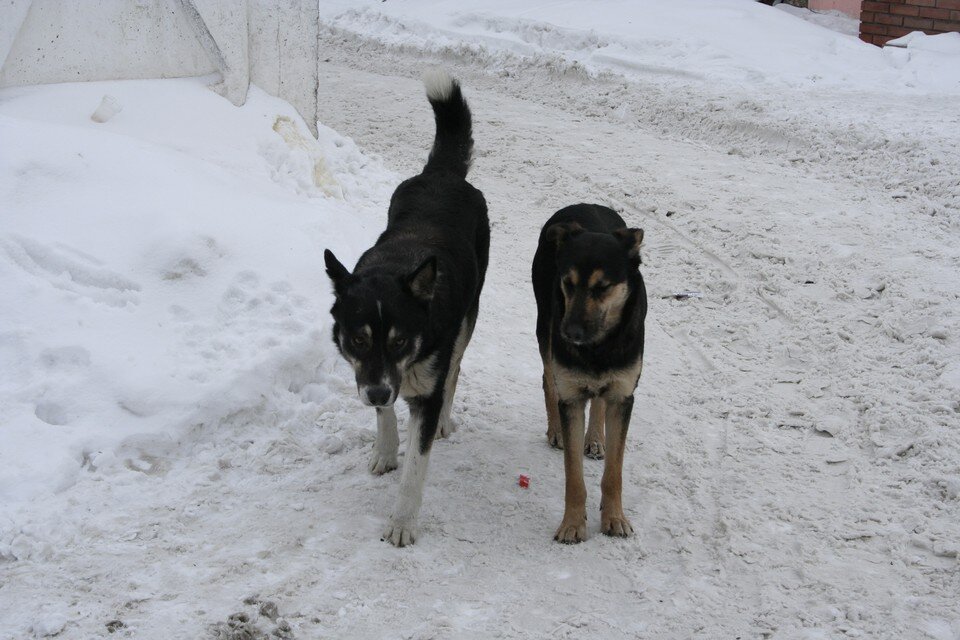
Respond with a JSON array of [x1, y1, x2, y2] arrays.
[[383, 391, 443, 547]]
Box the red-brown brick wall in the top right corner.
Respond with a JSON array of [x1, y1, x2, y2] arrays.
[[860, 0, 960, 45]]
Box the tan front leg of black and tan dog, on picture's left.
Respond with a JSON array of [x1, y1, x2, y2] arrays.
[[553, 397, 587, 543]]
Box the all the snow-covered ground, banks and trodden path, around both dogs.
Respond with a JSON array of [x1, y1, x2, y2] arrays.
[[0, 0, 960, 640]]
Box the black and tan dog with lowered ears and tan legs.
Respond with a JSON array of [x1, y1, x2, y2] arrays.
[[533, 204, 647, 543]]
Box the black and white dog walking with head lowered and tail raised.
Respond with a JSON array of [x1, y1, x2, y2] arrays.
[[324, 71, 490, 547]]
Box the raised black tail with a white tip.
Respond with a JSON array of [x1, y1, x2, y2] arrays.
[[423, 69, 473, 178]]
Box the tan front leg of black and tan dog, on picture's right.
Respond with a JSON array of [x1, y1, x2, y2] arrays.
[[600, 395, 633, 537]]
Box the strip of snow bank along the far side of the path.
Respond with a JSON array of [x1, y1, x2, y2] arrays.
[[320, 0, 960, 94]]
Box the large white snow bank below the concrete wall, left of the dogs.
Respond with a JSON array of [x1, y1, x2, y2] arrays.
[[0, 79, 395, 544]]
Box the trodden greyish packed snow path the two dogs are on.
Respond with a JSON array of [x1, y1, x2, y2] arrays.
[[0, 22, 960, 638]]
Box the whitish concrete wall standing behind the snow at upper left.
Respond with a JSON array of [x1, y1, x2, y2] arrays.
[[0, 0, 319, 133]]
